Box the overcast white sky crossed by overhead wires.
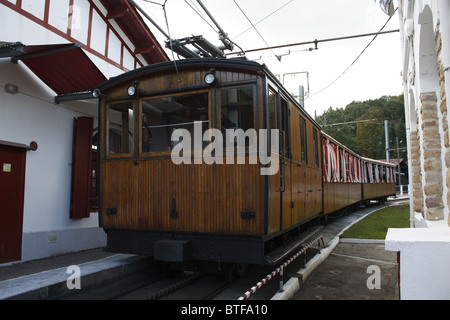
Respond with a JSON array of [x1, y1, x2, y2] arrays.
[[138, 0, 403, 116]]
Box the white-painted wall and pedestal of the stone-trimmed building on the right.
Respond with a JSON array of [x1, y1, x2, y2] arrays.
[[386, 0, 450, 300]]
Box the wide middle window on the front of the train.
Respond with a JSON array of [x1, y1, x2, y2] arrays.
[[141, 92, 209, 153]]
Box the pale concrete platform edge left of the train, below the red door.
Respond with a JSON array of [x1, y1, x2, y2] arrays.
[[0, 248, 149, 300]]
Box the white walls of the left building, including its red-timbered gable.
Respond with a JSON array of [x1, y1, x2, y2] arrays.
[[0, 0, 155, 260]]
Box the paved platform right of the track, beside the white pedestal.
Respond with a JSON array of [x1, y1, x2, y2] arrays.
[[289, 239, 400, 301]]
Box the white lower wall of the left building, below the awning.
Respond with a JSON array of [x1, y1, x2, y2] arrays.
[[0, 59, 105, 260]]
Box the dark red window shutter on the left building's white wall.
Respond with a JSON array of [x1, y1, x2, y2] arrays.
[[70, 117, 94, 219]]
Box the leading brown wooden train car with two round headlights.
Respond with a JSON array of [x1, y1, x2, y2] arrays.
[[96, 58, 394, 264]]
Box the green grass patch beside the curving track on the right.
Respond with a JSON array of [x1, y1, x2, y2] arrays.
[[341, 204, 409, 240]]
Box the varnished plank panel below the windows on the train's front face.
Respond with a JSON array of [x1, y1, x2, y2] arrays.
[[101, 158, 264, 234]]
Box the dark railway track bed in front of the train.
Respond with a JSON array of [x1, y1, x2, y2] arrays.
[[59, 235, 324, 301]]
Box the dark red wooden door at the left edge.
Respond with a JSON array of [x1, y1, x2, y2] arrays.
[[0, 145, 26, 263]]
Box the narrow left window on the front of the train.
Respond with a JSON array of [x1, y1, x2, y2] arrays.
[[107, 101, 134, 155]]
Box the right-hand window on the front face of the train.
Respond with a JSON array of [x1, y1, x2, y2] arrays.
[[220, 87, 255, 131]]
